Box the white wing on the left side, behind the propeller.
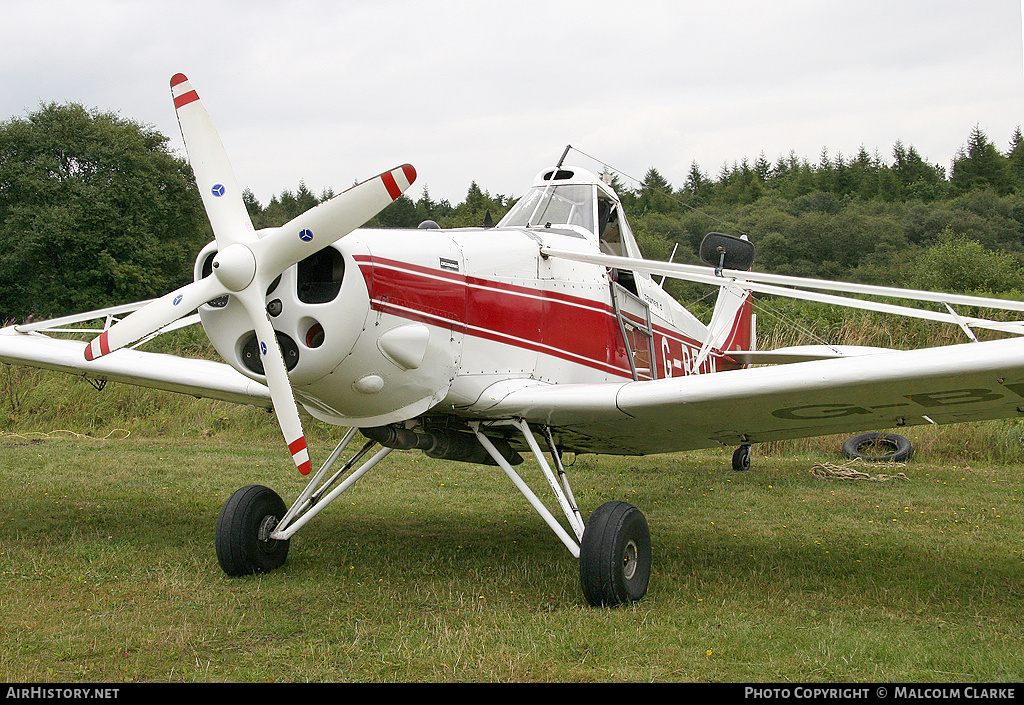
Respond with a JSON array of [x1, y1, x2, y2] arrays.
[[0, 327, 273, 409]]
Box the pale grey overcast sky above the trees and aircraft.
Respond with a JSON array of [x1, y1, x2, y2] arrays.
[[6, 0, 1024, 204]]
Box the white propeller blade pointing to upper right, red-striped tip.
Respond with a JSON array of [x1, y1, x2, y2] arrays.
[[251, 164, 416, 276]]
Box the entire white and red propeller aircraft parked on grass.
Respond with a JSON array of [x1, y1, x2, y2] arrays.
[[6, 74, 1024, 606]]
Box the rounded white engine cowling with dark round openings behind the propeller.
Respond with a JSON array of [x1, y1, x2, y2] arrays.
[[194, 231, 461, 426]]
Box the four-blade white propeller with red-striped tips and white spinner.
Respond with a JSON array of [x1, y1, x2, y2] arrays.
[[85, 74, 416, 474]]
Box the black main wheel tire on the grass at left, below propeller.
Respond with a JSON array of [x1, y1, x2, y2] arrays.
[[215, 485, 290, 576]]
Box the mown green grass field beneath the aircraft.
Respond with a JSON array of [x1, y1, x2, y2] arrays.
[[0, 381, 1024, 683]]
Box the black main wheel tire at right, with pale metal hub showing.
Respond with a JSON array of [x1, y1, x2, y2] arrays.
[[580, 502, 651, 607]]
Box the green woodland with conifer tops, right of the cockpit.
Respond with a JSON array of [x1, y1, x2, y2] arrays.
[[623, 127, 1024, 294]]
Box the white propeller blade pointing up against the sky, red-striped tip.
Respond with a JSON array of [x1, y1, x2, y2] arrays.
[[171, 74, 256, 249]]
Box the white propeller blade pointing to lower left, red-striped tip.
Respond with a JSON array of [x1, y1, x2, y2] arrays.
[[85, 277, 227, 360]]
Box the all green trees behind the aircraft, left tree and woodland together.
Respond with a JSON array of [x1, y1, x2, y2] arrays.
[[0, 103, 1024, 319]]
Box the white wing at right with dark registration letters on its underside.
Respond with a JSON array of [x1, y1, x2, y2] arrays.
[[472, 338, 1024, 455]]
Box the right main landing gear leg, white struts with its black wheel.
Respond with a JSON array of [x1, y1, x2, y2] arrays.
[[471, 419, 651, 607]]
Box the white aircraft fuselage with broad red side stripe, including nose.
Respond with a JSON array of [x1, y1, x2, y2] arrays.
[[197, 171, 749, 427]]
